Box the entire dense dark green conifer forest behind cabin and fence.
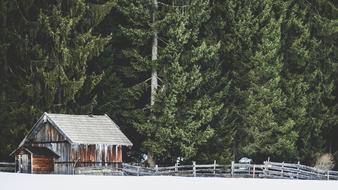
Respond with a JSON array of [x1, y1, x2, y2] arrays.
[[0, 0, 338, 165]]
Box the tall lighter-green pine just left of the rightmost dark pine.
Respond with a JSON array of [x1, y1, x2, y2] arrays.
[[242, 1, 298, 161]]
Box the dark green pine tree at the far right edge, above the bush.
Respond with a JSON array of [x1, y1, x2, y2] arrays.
[[283, 1, 337, 162]]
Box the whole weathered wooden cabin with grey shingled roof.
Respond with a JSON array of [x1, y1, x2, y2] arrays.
[[11, 113, 132, 174]]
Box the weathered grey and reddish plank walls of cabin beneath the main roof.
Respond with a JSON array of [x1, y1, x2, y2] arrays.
[[30, 123, 122, 174]]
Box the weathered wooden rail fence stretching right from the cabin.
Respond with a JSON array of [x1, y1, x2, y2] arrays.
[[122, 161, 338, 180]]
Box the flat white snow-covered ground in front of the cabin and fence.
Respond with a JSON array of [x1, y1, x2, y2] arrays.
[[0, 173, 338, 190]]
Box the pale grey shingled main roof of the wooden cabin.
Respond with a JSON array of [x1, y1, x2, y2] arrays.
[[42, 113, 133, 146]]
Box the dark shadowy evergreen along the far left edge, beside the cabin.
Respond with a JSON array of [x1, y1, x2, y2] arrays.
[[0, 0, 34, 160]]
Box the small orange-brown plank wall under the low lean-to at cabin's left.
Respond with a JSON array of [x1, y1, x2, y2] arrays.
[[32, 155, 54, 173]]
